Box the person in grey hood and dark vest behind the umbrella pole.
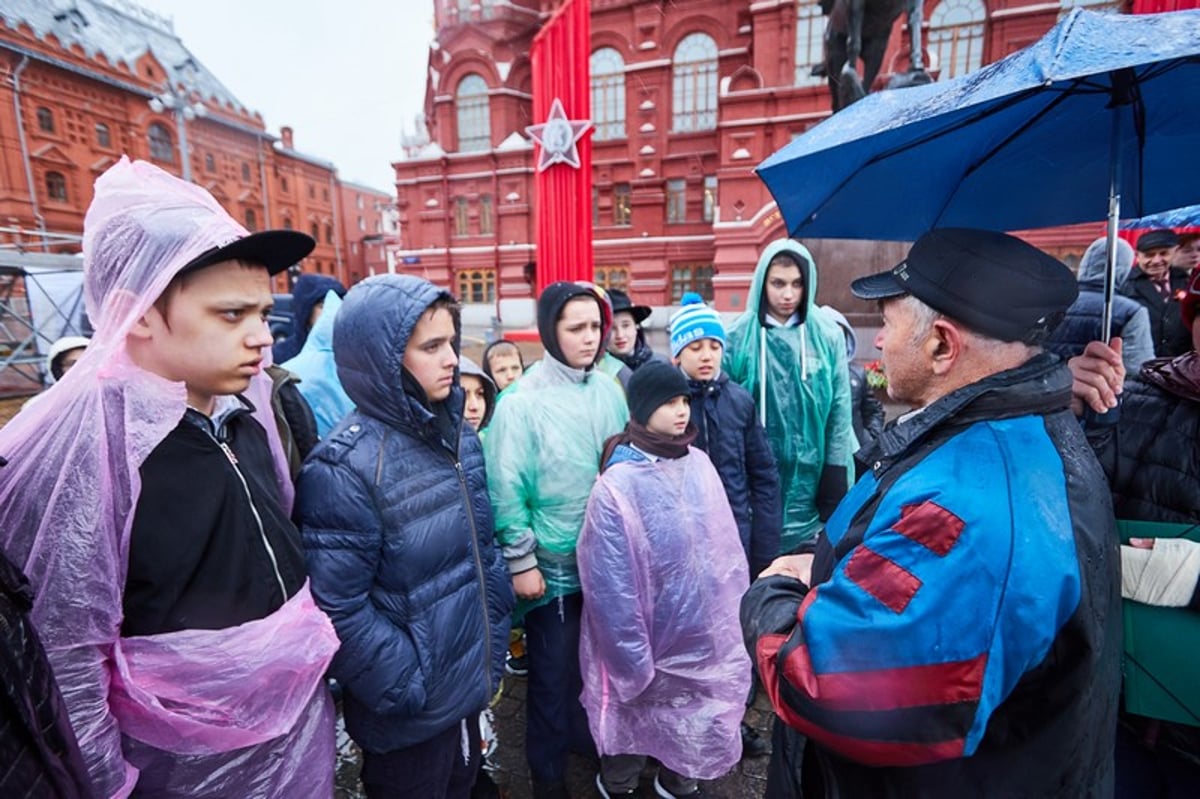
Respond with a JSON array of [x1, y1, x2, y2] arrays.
[[1046, 236, 1154, 374]]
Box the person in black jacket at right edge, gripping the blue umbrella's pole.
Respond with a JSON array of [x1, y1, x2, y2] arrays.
[[1072, 274, 1200, 799]]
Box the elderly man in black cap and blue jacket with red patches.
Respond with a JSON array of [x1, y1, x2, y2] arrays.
[[742, 229, 1120, 797]]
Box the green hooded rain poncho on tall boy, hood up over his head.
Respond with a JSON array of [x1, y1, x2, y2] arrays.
[[722, 239, 858, 552]]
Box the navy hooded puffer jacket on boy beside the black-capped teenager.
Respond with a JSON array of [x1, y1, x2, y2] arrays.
[[296, 275, 514, 752]]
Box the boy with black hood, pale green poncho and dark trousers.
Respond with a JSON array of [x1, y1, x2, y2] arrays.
[[484, 282, 629, 799]]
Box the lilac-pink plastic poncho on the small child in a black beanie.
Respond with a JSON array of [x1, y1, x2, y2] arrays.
[[576, 447, 750, 780]]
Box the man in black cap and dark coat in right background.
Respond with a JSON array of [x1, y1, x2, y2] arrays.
[[1122, 229, 1192, 358]]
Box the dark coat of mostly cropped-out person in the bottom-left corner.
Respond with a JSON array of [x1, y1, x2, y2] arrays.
[[0, 537, 92, 799]]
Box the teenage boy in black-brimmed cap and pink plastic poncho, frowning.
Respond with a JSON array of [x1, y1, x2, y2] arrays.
[[0, 158, 337, 797]]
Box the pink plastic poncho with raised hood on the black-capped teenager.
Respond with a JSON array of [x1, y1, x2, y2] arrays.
[[0, 158, 337, 797]]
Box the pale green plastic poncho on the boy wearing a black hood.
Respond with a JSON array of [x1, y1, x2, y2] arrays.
[[484, 356, 629, 618]]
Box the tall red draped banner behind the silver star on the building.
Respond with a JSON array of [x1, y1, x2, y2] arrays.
[[529, 0, 594, 291]]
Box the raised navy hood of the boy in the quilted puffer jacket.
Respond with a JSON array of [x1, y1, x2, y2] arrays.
[[334, 275, 462, 429]]
